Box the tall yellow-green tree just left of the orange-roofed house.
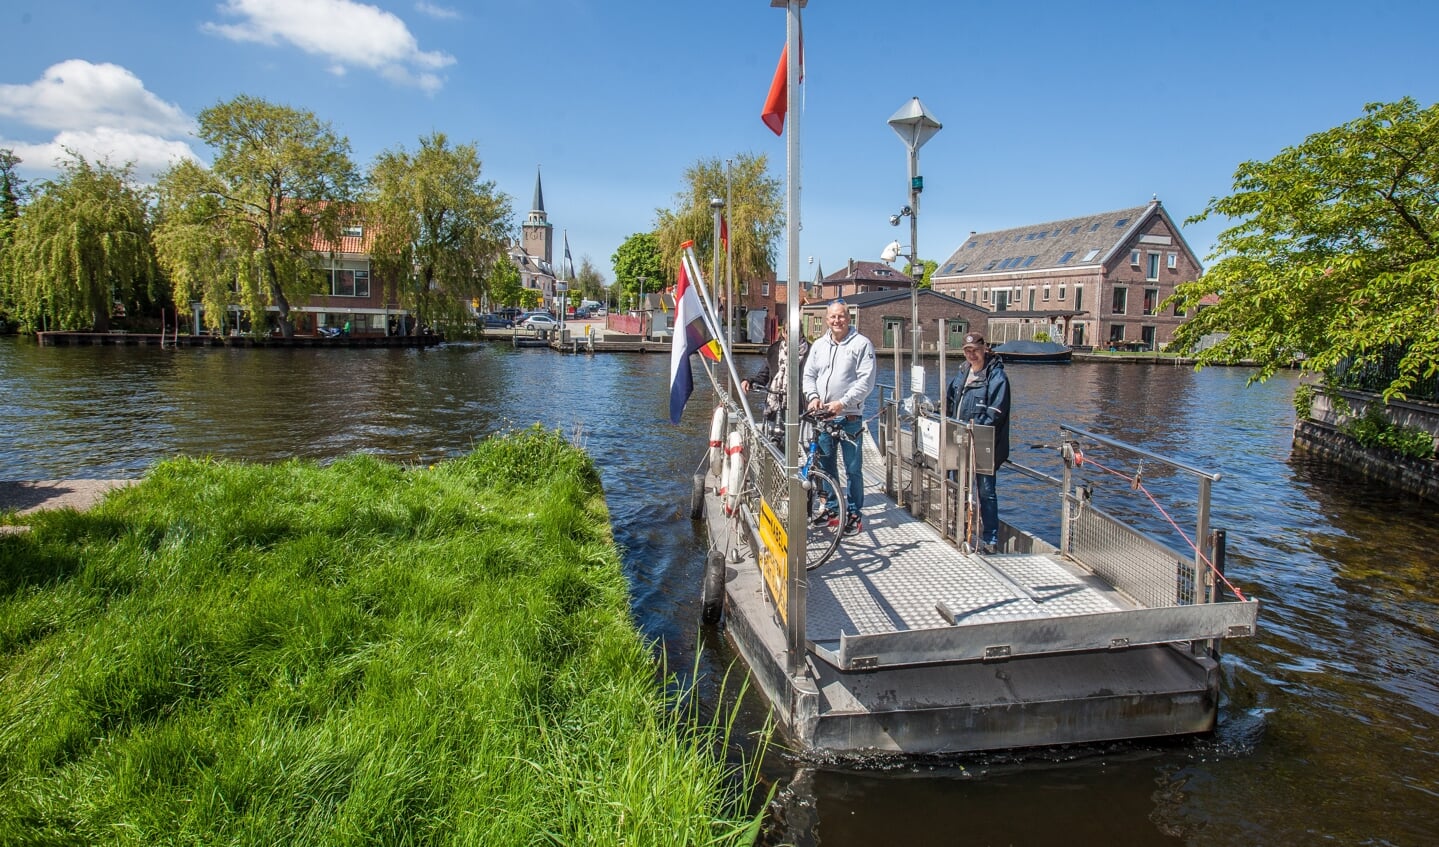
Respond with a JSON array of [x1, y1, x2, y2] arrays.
[[155, 95, 360, 338]]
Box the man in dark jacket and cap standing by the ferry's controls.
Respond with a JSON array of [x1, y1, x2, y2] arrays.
[[944, 332, 1009, 554]]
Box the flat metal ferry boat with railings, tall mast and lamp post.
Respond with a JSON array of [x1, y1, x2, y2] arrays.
[[671, 0, 1259, 758]]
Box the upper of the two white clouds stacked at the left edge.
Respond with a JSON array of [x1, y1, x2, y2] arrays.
[[0, 59, 194, 135]]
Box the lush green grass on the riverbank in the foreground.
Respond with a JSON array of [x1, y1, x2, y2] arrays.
[[0, 429, 758, 846]]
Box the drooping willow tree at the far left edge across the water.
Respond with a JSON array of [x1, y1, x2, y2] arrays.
[[3, 152, 155, 332]]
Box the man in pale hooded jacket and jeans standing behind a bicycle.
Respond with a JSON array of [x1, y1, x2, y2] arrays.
[[803, 301, 875, 535]]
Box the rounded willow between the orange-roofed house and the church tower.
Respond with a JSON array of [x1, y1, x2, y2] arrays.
[[370, 132, 514, 330]]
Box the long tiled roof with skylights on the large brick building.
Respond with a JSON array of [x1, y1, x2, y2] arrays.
[[932, 200, 1163, 279]]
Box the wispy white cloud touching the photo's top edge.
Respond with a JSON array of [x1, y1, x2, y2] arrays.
[[204, 0, 455, 92]]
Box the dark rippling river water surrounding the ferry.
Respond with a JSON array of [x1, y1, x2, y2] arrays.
[[0, 338, 1439, 847]]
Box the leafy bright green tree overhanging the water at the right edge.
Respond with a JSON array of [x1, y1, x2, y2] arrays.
[[1163, 98, 1439, 397]]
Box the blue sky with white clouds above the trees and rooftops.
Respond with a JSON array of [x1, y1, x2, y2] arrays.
[[0, 0, 1439, 286]]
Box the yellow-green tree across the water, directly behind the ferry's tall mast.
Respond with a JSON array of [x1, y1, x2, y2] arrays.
[[655, 154, 784, 289]]
